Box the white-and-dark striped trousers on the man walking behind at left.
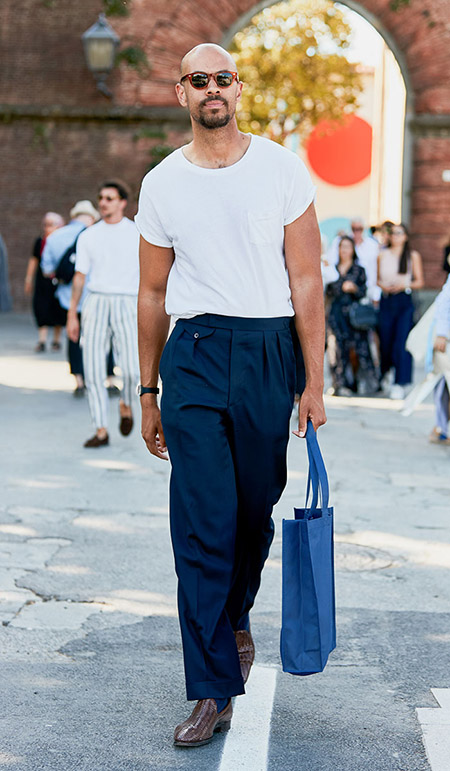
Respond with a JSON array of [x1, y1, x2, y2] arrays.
[[81, 292, 139, 429]]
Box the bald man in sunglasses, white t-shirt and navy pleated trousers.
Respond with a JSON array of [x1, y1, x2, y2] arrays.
[[135, 44, 326, 747]]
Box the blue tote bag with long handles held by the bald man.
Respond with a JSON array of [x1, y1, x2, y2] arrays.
[[280, 421, 336, 675]]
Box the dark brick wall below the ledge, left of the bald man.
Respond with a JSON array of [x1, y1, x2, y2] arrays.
[[0, 120, 187, 309]]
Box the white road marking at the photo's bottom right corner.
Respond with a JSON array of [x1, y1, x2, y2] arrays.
[[416, 688, 450, 771]]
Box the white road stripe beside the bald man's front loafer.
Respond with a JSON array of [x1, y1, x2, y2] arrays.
[[219, 665, 277, 771]]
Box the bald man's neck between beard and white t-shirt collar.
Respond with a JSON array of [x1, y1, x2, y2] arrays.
[[183, 121, 251, 169]]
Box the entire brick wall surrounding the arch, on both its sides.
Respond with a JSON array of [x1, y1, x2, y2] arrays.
[[0, 0, 450, 307]]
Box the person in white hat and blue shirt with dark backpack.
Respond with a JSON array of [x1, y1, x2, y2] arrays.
[[41, 200, 100, 396]]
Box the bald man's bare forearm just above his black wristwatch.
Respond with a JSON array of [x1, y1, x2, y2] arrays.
[[138, 289, 170, 388]]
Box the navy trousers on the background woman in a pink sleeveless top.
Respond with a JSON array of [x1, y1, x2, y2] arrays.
[[378, 292, 414, 385]]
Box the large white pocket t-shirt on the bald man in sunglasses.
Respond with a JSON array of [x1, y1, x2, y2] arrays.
[[135, 135, 315, 318]]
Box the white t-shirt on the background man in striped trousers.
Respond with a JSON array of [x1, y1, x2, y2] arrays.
[[75, 217, 139, 295]]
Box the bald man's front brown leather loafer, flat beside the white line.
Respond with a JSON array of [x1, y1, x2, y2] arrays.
[[173, 699, 233, 747]]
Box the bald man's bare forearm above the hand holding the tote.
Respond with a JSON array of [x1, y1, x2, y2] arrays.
[[292, 276, 325, 390]]
